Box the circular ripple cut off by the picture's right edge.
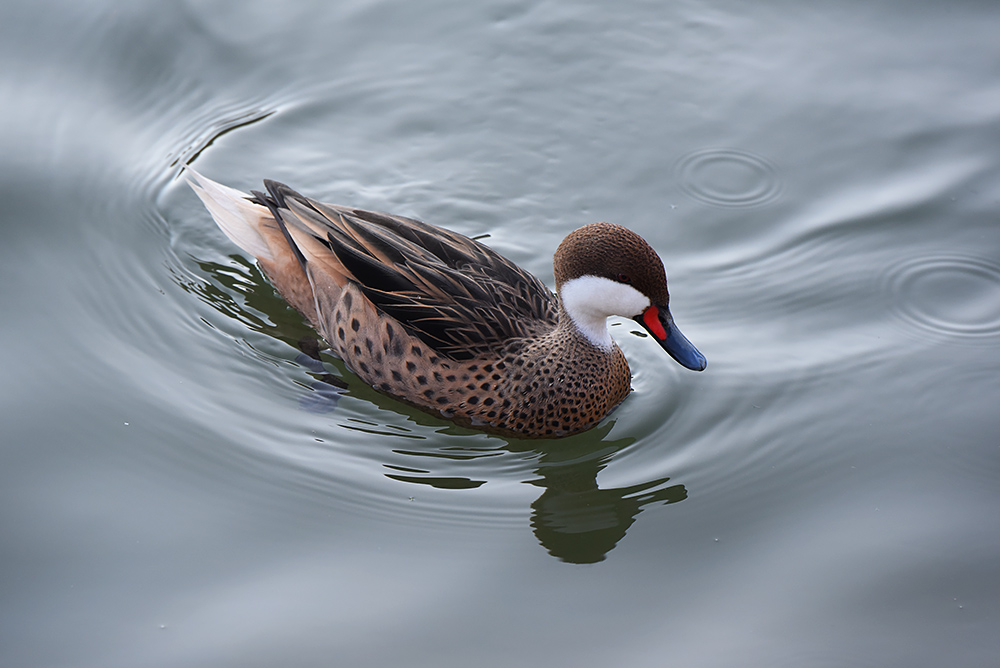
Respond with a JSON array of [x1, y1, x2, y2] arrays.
[[886, 255, 1000, 340]]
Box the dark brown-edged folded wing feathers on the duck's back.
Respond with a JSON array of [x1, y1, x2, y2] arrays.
[[255, 181, 558, 359]]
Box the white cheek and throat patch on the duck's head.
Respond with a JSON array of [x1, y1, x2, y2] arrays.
[[559, 276, 650, 350]]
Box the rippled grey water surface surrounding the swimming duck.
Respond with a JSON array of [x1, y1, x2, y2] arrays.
[[0, 0, 1000, 668]]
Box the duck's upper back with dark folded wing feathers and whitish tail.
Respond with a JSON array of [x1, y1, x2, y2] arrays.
[[188, 173, 558, 344]]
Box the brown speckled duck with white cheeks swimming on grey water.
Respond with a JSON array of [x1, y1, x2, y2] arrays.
[[186, 167, 706, 438]]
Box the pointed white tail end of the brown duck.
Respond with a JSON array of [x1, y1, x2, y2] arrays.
[[186, 167, 274, 261]]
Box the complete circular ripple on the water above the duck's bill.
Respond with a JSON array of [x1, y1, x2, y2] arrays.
[[677, 148, 781, 207]]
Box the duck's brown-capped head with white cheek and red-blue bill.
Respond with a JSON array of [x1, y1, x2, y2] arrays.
[[553, 223, 706, 371]]
